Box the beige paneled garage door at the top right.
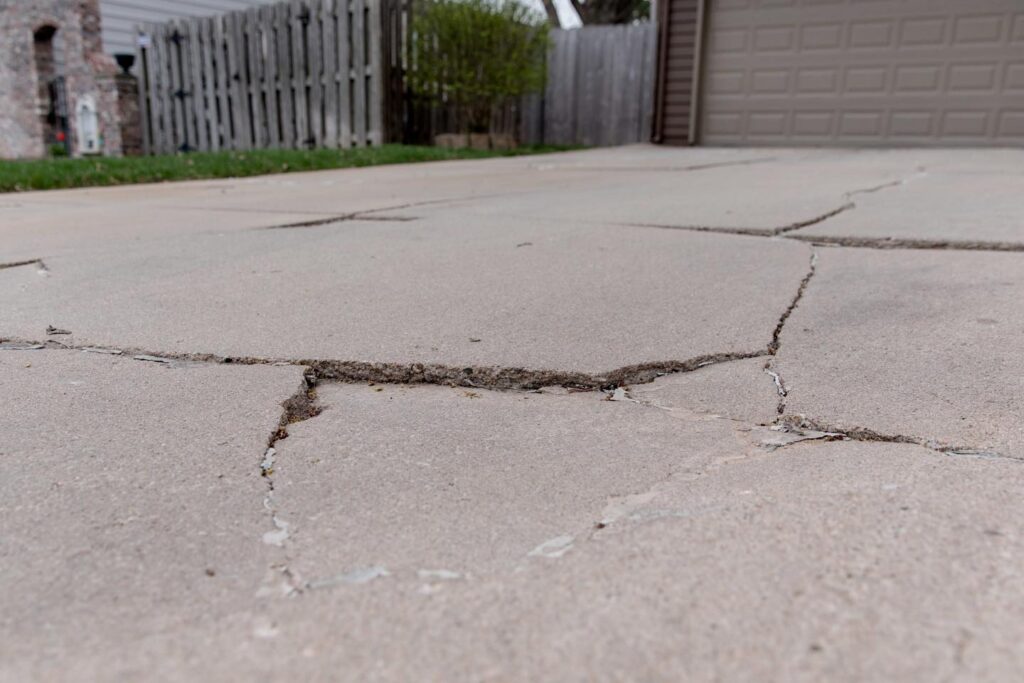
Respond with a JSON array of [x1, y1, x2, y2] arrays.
[[700, 0, 1024, 145]]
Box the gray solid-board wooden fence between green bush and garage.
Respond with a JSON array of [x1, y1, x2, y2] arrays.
[[536, 23, 657, 145]]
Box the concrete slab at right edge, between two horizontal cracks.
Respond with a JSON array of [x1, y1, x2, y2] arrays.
[[775, 249, 1024, 458]]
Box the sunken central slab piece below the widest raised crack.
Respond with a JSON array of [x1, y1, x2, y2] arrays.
[[264, 385, 755, 588]]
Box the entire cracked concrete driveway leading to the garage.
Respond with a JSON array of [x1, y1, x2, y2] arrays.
[[0, 146, 1024, 682]]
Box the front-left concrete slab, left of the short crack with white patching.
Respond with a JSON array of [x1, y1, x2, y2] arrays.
[[0, 350, 302, 681]]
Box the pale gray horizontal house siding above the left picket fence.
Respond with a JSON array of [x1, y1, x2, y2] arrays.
[[99, 0, 278, 54]]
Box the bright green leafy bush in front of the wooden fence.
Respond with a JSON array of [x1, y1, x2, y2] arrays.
[[409, 0, 548, 132]]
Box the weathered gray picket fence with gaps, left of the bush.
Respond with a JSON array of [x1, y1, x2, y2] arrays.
[[138, 0, 384, 154]]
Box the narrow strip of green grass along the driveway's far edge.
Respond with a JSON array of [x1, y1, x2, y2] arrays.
[[0, 144, 571, 193]]
